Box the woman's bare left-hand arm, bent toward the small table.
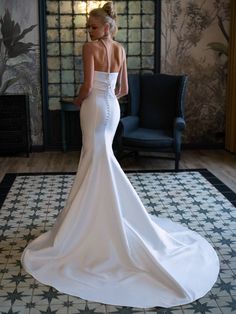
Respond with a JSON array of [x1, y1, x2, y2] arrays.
[[74, 43, 94, 106]]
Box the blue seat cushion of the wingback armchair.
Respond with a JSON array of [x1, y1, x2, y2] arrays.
[[122, 128, 173, 149]]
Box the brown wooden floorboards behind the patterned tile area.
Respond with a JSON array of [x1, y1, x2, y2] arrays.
[[0, 150, 236, 192]]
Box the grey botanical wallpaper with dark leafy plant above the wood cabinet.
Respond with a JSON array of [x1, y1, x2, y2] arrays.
[[0, 0, 43, 145]]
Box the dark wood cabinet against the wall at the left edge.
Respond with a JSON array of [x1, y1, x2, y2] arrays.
[[0, 95, 31, 156]]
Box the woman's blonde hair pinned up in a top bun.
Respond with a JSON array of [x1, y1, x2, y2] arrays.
[[89, 1, 118, 36]]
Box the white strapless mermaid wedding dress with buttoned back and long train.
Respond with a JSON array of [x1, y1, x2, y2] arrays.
[[22, 39, 219, 308]]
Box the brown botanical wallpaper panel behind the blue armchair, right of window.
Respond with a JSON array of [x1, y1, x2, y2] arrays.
[[161, 0, 230, 144]]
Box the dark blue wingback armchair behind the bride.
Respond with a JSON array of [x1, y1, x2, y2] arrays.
[[120, 74, 187, 170]]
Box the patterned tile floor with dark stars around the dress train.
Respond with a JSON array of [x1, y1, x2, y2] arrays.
[[0, 170, 236, 314]]
